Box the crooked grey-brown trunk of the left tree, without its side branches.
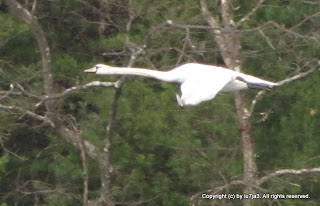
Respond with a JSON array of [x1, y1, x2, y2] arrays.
[[4, 0, 114, 206]]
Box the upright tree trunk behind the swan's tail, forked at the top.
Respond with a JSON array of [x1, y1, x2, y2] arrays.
[[200, 0, 257, 206]]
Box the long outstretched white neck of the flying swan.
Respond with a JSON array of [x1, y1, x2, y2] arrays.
[[97, 67, 179, 82]]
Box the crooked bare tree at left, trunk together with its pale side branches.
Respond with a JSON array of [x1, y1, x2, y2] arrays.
[[0, 0, 113, 205]]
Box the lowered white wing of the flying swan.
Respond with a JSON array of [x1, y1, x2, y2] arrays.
[[177, 75, 232, 106]]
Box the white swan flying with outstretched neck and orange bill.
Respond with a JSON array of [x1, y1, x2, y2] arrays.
[[85, 63, 278, 106]]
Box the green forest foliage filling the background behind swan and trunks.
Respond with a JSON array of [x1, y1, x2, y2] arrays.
[[0, 0, 320, 206]]
